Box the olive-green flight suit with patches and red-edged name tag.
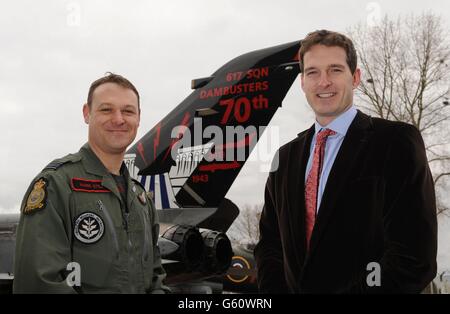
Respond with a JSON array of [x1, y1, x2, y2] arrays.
[[13, 144, 167, 293]]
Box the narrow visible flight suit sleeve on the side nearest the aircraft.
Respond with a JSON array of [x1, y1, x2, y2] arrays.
[[148, 199, 170, 294]]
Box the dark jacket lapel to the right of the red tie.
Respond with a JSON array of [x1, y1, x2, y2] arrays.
[[310, 110, 371, 255]]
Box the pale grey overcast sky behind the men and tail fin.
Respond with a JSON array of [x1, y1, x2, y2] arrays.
[[0, 0, 450, 272]]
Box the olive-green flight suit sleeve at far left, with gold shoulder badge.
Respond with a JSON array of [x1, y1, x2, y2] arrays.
[[13, 175, 76, 293]]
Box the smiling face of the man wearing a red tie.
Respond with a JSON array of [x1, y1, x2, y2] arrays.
[[301, 44, 361, 126]]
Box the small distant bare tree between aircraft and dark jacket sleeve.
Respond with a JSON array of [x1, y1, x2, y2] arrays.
[[228, 204, 262, 245]]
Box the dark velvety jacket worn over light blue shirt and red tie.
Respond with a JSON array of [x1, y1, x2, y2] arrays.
[[255, 111, 437, 293]]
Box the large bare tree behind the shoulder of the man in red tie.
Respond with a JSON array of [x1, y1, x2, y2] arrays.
[[349, 13, 450, 213]]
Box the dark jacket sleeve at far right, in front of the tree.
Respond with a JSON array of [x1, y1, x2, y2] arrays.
[[350, 125, 437, 293]]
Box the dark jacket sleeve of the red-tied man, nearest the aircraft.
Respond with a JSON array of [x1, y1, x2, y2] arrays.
[[254, 153, 288, 293]]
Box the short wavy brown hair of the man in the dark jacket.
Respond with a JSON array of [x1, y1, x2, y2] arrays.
[[298, 29, 358, 74]]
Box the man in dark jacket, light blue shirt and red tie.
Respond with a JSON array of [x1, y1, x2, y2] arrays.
[[255, 30, 437, 293]]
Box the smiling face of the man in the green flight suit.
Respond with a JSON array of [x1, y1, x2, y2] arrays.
[[83, 83, 140, 155]]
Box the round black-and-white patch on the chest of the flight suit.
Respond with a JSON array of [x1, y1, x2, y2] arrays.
[[74, 212, 105, 244]]
